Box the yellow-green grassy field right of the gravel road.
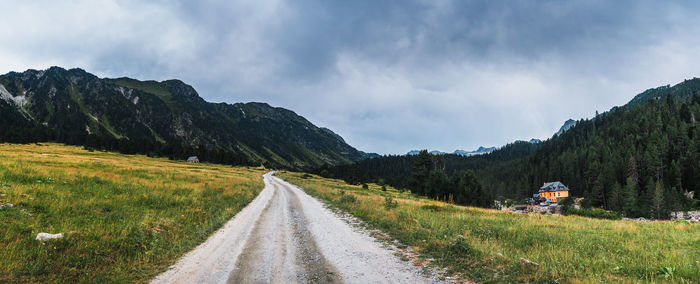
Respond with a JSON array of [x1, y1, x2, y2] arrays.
[[278, 172, 700, 283]]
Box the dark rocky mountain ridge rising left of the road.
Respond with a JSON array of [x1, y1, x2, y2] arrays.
[[0, 67, 368, 169]]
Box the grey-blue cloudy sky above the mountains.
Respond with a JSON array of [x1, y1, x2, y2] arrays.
[[0, 0, 700, 154]]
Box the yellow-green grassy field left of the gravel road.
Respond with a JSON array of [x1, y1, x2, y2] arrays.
[[0, 144, 263, 283]]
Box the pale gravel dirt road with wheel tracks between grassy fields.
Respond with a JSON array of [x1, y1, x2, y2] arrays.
[[152, 173, 433, 283]]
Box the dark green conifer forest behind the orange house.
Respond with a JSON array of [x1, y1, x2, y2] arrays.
[[316, 91, 700, 219]]
